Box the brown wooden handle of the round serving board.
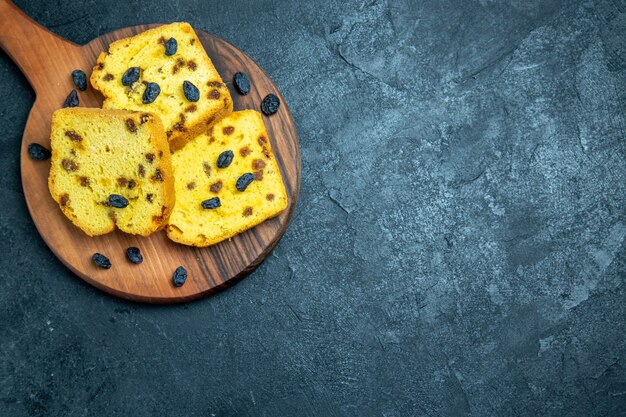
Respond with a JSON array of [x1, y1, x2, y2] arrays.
[[0, 0, 80, 92]]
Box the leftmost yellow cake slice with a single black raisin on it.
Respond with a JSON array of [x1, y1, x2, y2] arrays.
[[48, 108, 175, 236]]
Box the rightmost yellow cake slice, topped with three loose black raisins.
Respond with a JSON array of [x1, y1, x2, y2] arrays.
[[165, 110, 288, 246]]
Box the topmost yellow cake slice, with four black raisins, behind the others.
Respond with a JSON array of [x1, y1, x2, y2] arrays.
[[91, 23, 233, 150]]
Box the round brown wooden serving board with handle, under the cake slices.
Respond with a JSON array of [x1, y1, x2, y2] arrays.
[[0, 0, 301, 303]]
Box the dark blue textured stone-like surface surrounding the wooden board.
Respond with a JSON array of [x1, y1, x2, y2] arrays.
[[0, 0, 626, 417]]
